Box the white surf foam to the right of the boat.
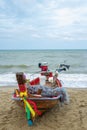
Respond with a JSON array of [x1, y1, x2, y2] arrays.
[[59, 74, 87, 88]]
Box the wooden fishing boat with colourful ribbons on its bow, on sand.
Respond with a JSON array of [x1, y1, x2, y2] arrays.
[[12, 63, 67, 126]]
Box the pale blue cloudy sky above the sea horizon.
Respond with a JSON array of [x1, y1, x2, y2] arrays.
[[0, 0, 87, 50]]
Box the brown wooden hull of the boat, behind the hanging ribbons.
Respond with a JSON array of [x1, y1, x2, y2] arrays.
[[12, 95, 61, 114]]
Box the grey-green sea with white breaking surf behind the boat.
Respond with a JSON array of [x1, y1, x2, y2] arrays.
[[0, 50, 87, 88]]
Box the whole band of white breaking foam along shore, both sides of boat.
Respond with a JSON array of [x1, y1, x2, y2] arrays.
[[0, 73, 87, 88]]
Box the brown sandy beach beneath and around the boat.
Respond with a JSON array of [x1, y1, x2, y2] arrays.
[[0, 88, 87, 130]]
